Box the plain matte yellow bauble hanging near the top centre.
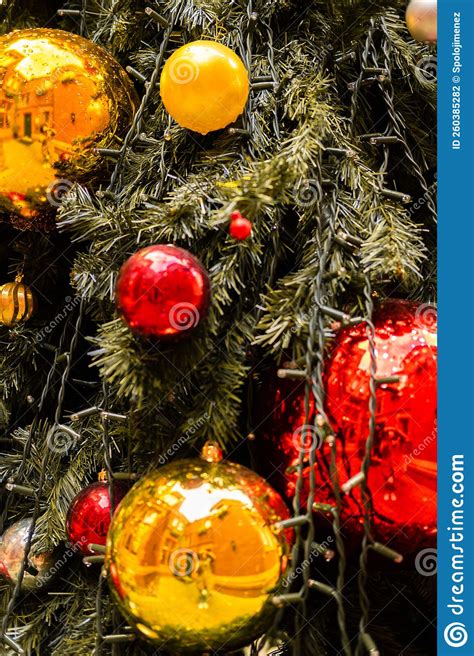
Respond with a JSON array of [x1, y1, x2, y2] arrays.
[[160, 41, 249, 134]]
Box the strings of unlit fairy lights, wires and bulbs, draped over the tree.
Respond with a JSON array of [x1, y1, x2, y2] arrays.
[[0, 0, 436, 656]]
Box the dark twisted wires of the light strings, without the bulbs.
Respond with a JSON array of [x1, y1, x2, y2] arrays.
[[0, 6, 424, 656]]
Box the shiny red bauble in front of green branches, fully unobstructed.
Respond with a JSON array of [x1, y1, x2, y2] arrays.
[[116, 245, 210, 339]]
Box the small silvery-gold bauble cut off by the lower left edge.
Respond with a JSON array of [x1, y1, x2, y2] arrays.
[[0, 518, 57, 590]]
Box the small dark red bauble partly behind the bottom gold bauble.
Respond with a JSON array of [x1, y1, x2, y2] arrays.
[[66, 482, 126, 556]]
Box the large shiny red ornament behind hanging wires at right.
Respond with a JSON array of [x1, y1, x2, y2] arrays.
[[261, 301, 437, 553]]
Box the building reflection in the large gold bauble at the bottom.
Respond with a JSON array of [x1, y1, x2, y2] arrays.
[[116, 490, 280, 596]]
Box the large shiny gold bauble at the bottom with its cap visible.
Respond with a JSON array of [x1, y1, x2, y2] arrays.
[[106, 452, 289, 654]]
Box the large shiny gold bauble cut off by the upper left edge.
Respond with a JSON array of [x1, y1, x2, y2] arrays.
[[0, 28, 138, 219]]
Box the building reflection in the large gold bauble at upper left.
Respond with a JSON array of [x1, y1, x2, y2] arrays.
[[0, 39, 110, 192]]
